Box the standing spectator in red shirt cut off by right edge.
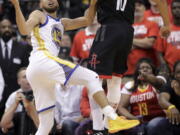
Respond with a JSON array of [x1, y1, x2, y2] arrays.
[[156, 0, 180, 71]]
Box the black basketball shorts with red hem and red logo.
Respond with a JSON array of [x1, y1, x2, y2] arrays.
[[88, 22, 134, 79]]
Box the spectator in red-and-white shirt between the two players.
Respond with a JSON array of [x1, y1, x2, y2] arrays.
[[70, 17, 99, 63]]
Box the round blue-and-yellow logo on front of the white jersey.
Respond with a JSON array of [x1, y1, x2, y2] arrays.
[[51, 24, 62, 48]]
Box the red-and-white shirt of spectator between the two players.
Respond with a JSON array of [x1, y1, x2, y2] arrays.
[[70, 28, 95, 59]]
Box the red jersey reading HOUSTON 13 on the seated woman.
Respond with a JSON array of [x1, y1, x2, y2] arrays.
[[130, 85, 164, 122]]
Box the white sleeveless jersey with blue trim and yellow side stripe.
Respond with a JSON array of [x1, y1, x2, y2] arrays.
[[31, 15, 64, 56]]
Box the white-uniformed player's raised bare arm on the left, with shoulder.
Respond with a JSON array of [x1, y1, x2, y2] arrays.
[[10, 0, 41, 35]]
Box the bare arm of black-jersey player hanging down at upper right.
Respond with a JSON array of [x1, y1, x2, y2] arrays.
[[153, 0, 170, 37]]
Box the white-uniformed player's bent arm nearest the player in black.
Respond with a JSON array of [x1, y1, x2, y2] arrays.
[[62, 0, 97, 30]]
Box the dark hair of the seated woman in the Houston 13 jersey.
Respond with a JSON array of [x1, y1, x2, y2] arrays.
[[129, 58, 156, 91]]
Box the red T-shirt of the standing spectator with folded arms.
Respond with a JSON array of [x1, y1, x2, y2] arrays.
[[125, 19, 159, 75]]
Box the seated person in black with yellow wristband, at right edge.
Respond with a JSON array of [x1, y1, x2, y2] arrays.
[[147, 60, 180, 135]]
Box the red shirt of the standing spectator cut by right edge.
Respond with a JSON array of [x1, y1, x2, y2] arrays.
[[156, 25, 180, 70]]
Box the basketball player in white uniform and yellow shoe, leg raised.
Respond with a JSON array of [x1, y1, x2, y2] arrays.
[[11, 0, 139, 135]]
